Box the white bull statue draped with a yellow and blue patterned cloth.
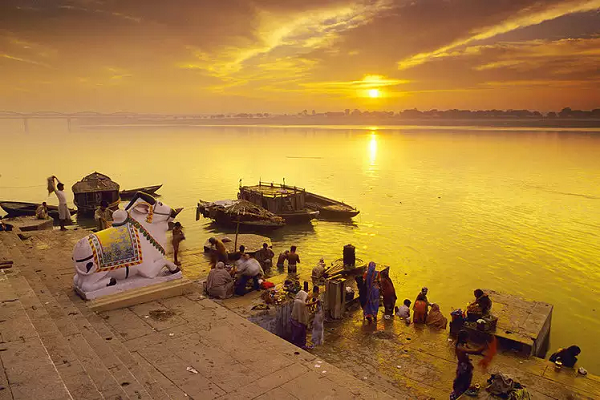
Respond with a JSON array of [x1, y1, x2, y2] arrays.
[[73, 192, 180, 293]]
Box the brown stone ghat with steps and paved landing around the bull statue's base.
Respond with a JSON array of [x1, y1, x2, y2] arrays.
[[0, 230, 392, 400]]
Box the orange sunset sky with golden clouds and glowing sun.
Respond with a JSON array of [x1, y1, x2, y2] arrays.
[[0, 0, 600, 113]]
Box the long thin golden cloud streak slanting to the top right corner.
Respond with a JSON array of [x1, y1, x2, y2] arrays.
[[398, 0, 600, 70]]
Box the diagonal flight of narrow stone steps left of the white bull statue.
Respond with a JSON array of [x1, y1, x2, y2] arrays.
[[0, 231, 169, 399]]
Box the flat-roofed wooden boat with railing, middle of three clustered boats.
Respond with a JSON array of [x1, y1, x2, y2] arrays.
[[238, 182, 319, 224]]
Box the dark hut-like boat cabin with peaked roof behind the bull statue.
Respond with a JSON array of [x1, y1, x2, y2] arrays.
[[72, 172, 120, 214]]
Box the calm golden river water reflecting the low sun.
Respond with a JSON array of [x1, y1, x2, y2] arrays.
[[0, 121, 600, 373]]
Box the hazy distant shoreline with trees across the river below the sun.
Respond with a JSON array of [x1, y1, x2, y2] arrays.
[[77, 117, 600, 130]]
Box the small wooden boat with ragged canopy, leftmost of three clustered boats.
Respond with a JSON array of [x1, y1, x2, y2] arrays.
[[196, 200, 285, 230]]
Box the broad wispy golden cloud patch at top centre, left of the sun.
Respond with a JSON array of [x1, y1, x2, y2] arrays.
[[178, 0, 393, 91]]
